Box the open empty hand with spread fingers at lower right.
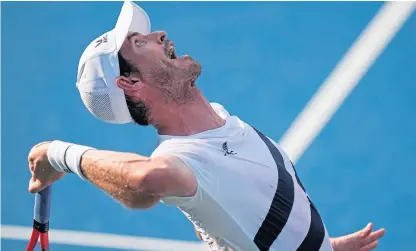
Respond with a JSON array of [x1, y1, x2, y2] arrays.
[[331, 223, 385, 251]]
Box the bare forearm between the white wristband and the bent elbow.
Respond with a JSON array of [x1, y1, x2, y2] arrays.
[[81, 150, 160, 208]]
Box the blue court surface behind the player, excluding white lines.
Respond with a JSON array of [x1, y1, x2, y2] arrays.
[[1, 2, 416, 251]]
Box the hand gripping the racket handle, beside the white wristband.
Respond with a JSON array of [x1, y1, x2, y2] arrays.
[[28, 142, 65, 193]]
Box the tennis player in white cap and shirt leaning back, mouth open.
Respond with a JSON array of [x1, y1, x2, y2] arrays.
[[29, 1, 384, 251]]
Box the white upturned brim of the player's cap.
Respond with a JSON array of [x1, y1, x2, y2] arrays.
[[113, 1, 151, 51]]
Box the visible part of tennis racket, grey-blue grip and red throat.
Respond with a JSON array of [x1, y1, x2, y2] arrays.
[[26, 186, 52, 251]]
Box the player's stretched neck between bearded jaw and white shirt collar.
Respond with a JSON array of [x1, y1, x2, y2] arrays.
[[151, 93, 225, 136]]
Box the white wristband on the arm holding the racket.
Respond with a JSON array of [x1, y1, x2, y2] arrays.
[[47, 140, 94, 180]]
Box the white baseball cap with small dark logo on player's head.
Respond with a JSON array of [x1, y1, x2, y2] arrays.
[[77, 1, 150, 124]]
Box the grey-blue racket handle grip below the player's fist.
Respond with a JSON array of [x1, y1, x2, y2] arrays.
[[34, 185, 52, 226]]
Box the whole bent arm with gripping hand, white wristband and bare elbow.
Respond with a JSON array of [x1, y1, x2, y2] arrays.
[[29, 142, 196, 209]]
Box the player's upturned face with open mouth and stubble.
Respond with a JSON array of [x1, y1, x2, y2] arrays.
[[120, 32, 201, 124]]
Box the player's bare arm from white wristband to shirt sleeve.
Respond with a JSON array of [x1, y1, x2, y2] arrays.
[[81, 150, 196, 208]]
